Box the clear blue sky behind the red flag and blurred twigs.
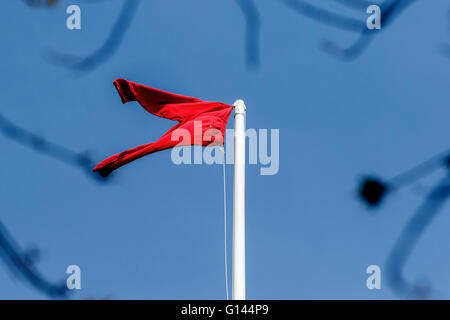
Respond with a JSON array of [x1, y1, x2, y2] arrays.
[[0, 0, 450, 299]]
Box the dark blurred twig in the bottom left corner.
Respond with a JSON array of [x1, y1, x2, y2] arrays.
[[0, 222, 68, 299]]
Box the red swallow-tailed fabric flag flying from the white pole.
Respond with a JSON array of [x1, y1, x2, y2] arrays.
[[93, 79, 233, 177]]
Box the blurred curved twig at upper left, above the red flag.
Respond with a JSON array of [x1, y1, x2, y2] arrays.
[[46, 0, 140, 72]]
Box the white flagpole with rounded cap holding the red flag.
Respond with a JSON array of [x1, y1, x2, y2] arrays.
[[232, 100, 246, 300]]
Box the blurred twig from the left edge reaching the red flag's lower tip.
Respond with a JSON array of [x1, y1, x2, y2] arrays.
[[0, 114, 107, 182]]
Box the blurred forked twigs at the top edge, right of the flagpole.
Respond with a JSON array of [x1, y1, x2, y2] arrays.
[[281, 0, 416, 61]]
